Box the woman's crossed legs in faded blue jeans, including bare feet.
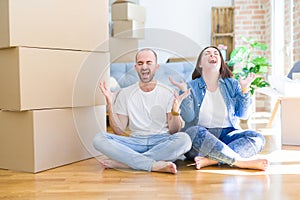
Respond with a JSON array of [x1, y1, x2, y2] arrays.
[[186, 126, 269, 170]]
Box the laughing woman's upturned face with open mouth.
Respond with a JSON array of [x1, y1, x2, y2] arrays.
[[199, 47, 221, 72]]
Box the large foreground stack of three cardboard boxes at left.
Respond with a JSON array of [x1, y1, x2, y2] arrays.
[[0, 0, 110, 173]]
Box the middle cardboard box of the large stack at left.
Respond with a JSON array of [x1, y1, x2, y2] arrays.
[[0, 47, 109, 111]]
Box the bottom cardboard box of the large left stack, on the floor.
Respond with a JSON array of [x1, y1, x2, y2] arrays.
[[0, 106, 106, 173]]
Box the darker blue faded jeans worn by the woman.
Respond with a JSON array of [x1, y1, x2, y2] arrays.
[[185, 126, 265, 166]]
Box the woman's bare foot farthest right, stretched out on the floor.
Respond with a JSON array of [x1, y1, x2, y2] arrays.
[[233, 159, 269, 171]]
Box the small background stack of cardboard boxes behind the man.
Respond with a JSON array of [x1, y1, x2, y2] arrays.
[[109, 0, 146, 62]]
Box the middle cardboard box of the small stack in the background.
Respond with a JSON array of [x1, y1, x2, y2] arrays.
[[113, 20, 145, 38]]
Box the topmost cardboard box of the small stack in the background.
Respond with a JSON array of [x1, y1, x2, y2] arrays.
[[111, 2, 146, 22]]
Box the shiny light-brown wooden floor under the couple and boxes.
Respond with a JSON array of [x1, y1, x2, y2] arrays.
[[0, 123, 300, 200]]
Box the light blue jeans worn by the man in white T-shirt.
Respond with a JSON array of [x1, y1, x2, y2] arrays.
[[93, 132, 192, 171]]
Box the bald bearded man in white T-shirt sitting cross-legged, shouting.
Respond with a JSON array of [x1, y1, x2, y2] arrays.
[[93, 49, 191, 174]]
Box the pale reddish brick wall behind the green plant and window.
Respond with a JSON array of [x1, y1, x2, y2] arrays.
[[233, 0, 300, 111]]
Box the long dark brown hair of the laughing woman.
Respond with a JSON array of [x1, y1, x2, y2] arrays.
[[192, 46, 233, 80]]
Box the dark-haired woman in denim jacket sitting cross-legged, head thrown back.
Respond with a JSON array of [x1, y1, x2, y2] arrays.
[[170, 46, 269, 170]]
